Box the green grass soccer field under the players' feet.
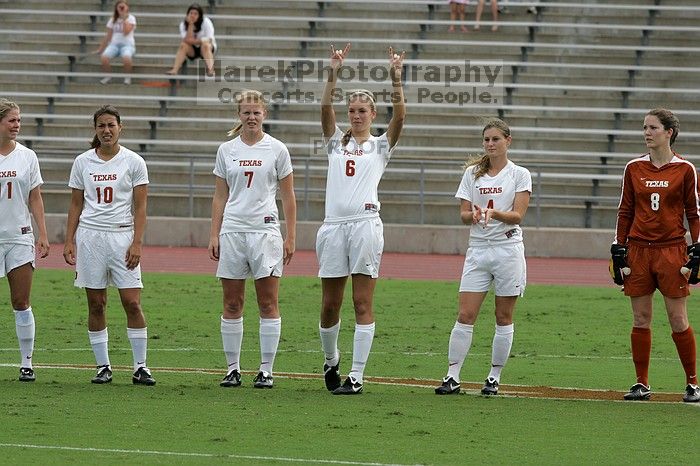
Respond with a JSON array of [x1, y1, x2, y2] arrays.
[[0, 270, 700, 464]]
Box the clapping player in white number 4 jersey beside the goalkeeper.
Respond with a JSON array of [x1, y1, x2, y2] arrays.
[[435, 119, 532, 395]]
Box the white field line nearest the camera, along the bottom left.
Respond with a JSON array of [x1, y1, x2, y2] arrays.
[[0, 443, 410, 466]]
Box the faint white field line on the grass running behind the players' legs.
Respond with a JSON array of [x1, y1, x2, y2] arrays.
[[0, 345, 678, 361]]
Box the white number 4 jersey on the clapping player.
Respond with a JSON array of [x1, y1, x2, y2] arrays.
[[455, 161, 532, 246]]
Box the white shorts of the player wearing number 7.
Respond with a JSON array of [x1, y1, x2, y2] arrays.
[[216, 232, 283, 280]]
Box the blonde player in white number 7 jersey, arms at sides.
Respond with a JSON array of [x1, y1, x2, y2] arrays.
[[209, 91, 296, 388]]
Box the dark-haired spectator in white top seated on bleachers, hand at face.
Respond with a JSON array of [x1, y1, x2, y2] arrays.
[[166, 3, 216, 76]]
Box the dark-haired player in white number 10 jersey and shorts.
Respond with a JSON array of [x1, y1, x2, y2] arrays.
[[63, 105, 156, 385]]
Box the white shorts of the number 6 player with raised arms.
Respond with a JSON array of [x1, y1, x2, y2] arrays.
[[316, 217, 384, 278]]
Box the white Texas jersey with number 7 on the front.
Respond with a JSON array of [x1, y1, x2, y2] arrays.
[[214, 134, 292, 236]]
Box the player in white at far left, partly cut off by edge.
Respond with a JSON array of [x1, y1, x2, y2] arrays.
[[0, 98, 49, 382]]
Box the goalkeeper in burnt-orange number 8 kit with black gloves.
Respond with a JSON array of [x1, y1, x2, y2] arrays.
[[611, 109, 700, 402]]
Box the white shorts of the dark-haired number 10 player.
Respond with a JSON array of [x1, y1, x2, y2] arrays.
[[74, 226, 143, 290]]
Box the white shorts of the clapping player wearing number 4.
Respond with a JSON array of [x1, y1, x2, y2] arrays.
[[459, 243, 527, 296]]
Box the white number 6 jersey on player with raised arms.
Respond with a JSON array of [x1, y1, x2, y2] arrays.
[[324, 126, 396, 223]]
